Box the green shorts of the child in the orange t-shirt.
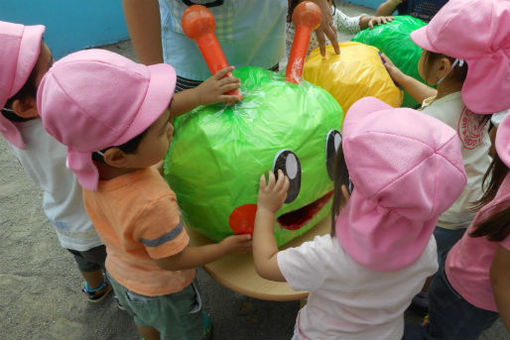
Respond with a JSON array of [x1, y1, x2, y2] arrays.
[[107, 274, 204, 340]]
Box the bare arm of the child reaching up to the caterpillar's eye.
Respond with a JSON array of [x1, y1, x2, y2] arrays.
[[253, 170, 289, 281]]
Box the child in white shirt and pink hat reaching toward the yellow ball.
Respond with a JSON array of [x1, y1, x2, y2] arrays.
[[383, 0, 502, 265]]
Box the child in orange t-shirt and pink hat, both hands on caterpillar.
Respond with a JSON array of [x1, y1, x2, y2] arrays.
[[37, 49, 251, 340]]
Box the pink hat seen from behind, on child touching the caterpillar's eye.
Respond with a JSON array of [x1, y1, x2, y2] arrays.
[[335, 97, 466, 272]]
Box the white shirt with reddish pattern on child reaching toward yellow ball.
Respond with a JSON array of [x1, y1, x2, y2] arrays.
[[421, 91, 492, 229]]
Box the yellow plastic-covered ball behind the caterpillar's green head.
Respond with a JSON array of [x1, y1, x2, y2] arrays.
[[304, 42, 402, 112]]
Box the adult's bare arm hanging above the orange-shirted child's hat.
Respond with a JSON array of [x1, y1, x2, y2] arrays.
[[123, 0, 163, 65]]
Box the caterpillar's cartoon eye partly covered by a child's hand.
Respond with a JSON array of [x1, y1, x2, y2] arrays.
[[273, 150, 301, 203]]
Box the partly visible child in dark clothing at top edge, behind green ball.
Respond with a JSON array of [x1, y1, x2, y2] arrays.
[[376, 0, 448, 21]]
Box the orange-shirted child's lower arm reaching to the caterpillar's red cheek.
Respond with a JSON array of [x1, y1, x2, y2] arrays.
[[154, 234, 251, 270]]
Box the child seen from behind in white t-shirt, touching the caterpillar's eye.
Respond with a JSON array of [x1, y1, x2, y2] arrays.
[[253, 97, 466, 339]]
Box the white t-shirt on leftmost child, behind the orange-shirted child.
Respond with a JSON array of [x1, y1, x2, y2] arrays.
[[11, 119, 103, 251]]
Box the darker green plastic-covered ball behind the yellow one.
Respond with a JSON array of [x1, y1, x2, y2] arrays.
[[352, 15, 427, 108]]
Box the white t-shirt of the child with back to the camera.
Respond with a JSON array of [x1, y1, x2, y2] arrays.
[[277, 235, 437, 340]]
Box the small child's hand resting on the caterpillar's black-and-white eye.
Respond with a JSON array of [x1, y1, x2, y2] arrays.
[[257, 170, 290, 214]]
